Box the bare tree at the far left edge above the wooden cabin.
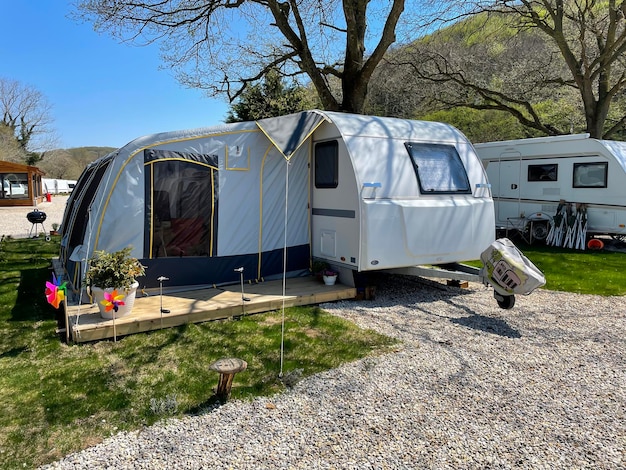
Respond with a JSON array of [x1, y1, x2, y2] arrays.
[[0, 77, 54, 165]]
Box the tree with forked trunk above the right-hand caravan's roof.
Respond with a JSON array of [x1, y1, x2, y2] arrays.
[[490, 0, 626, 138]]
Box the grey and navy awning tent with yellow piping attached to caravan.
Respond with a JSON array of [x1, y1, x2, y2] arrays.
[[61, 112, 325, 287]]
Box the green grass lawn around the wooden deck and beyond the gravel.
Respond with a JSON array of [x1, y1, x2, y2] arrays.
[[0, 237, 626, 469]]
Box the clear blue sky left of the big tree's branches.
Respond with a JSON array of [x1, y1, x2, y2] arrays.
[[0, 0, 228, 148]]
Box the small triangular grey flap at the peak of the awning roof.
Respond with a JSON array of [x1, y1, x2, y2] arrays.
[[256, 111, 326, 159]]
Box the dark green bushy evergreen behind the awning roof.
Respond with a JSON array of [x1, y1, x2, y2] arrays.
[[226, 70, 315, 122]]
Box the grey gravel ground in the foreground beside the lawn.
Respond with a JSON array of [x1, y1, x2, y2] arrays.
[[41, 277, 626, 469]]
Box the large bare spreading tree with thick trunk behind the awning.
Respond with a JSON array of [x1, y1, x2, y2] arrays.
[[76, 0, 404, 113]]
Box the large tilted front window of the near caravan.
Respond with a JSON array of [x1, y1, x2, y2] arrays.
[[405, 142, 471, 194]]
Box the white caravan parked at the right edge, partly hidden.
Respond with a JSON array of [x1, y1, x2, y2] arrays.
[[475, 134, 626, 240]]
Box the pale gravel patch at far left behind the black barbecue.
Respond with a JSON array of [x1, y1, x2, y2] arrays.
[[0, 195, 69, 238]]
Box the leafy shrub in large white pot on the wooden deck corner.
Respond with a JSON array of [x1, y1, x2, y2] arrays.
[[85, 247, 145, 318]]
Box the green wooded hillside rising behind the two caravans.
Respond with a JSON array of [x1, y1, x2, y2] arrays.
[[366, 0, 626, 142]]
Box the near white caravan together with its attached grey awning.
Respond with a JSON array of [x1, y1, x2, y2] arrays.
[[60, 111, 536, 308]]
